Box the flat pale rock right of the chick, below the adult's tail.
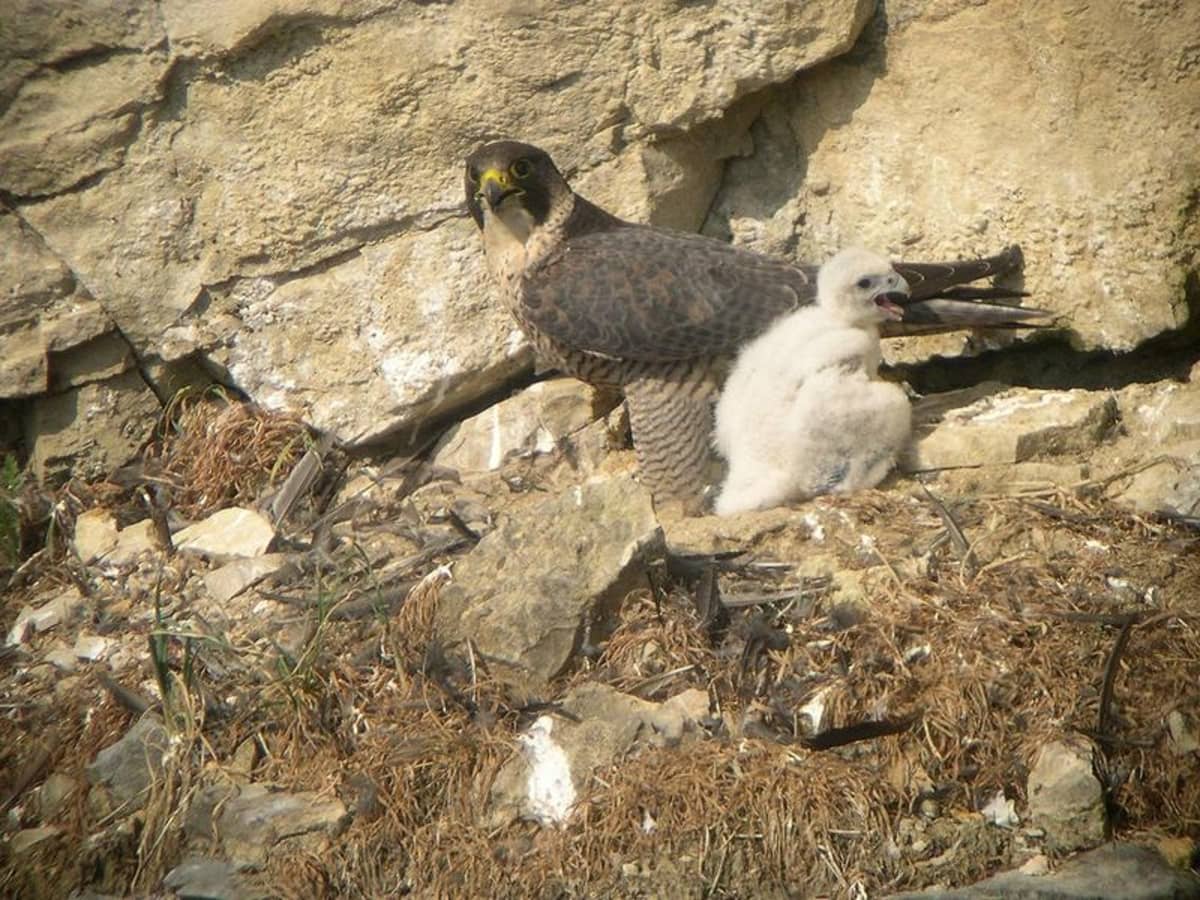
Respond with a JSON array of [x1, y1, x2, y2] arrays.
[[901, 388, 1117, 472]]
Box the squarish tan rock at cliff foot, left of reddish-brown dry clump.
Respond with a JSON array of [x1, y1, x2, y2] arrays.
[[24, 371, 160, 481]]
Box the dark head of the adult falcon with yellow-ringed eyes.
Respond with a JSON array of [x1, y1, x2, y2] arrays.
[[464, 140, 571, 241]]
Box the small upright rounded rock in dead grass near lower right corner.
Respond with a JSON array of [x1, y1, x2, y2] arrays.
[[1027, 740, 1105, 851]]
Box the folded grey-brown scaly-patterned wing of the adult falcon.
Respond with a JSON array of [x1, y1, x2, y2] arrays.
[[522, 224, 816, 362]]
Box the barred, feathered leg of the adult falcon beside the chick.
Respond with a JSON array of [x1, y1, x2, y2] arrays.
[[624, 366, 715, 512]]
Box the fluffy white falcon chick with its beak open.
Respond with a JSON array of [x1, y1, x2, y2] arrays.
[[714, 248, 912, 516]]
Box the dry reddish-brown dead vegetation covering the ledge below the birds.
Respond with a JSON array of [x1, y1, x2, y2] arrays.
[[0, 402, 1200, 898]]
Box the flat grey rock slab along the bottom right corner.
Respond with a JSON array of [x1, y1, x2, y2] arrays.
[[888, 844, 1200, 900]]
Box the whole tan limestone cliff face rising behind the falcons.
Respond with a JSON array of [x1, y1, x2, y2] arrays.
[[0, 0, 1200, 474]]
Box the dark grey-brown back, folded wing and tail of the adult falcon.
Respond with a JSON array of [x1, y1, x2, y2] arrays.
[[521, 207, 1048, 362]]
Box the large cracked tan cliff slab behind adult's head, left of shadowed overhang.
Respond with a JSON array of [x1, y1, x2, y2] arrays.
[[7, 0, 872, 443]]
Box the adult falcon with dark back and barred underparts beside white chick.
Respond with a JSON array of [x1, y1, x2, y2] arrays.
[[466, 140, 1045, 505]]
